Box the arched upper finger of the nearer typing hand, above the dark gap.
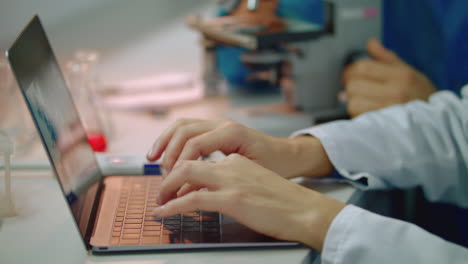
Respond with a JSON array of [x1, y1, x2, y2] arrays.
[[158, 160, 220, 204]]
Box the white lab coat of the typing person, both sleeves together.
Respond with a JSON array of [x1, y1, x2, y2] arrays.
[[293, 85, 468, 264]]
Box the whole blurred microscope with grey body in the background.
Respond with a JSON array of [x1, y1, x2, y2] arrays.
[[187, 0, 382, 119]]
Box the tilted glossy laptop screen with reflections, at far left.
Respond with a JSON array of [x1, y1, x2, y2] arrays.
[[7, 16, 102, 239]]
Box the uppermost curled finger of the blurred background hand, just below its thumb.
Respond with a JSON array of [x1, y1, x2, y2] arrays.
[[343, 59, 397, 85]]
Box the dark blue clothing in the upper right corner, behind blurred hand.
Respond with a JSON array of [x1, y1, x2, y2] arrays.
[[383, 0, 468, 94]]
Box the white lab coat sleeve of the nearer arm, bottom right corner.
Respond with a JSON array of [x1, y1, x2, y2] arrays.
[[321, 205, 468, 264]]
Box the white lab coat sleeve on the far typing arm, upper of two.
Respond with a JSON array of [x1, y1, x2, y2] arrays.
[[292, 85, 468, 208]]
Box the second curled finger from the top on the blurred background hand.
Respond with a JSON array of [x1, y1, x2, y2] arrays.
[[345, 79, 392, 101]]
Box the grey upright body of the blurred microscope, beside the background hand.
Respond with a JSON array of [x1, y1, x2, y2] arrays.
[[288, 0, 382, 116]]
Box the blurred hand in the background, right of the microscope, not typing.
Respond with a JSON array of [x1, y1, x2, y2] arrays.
[[343, 39, 436, 117]]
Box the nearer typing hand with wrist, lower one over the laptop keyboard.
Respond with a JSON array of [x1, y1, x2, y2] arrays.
[[154, 154, 345, 250]]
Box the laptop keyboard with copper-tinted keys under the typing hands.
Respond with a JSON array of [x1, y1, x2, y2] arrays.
[[111, 176, 221, 245]]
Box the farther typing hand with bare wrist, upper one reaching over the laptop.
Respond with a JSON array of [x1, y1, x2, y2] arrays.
[[147, 119, 333, 178]]
